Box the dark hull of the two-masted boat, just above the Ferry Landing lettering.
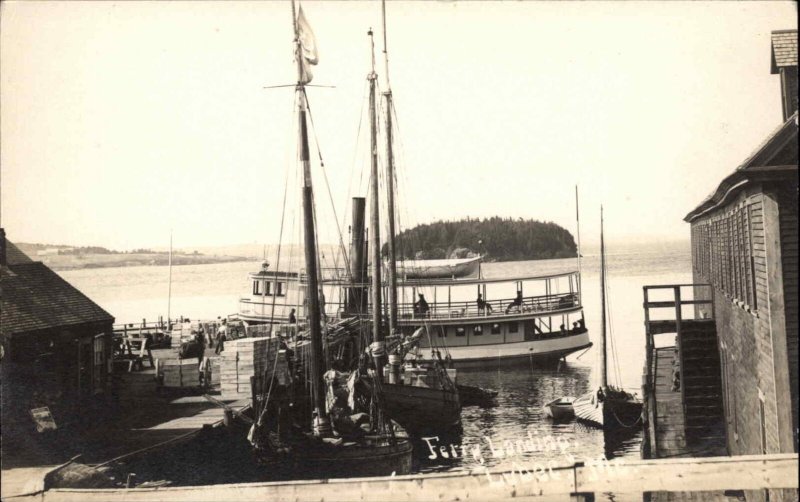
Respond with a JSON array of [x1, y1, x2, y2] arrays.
[[381, 382, 461, 436]]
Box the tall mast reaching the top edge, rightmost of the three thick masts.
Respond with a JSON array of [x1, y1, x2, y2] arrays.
[[381, 0, 397, 334]]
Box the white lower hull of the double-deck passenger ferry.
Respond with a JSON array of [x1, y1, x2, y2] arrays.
[[422, 332, 592, 369]]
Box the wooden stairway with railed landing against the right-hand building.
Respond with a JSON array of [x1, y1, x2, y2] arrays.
[[643, 284, 727, 458]]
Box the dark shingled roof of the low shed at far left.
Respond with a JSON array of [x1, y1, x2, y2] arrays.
[[0, 260, 114, 337]]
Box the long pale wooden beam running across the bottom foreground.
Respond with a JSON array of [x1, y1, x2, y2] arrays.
[[4, 454, 798, 502]]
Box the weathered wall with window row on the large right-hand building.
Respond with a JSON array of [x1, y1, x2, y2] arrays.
[[691, 181, 798, 455]]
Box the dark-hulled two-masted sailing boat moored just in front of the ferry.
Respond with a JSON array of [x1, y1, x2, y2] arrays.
[[365, 0, 461, 436]]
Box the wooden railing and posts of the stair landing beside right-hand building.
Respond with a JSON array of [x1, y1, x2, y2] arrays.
[[643, 283, 714, 451]]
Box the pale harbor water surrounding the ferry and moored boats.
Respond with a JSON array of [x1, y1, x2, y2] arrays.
[[61, 246, 691, 481]]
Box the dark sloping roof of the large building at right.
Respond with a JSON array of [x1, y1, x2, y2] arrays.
[[683, 112, 798, 222]]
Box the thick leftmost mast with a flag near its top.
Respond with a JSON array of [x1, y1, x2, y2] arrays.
[[292, 0, 331, 436]]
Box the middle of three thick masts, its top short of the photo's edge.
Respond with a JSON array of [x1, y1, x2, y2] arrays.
[[367, 29, 383, 372]]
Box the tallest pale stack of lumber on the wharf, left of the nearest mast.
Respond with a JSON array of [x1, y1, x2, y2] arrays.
[[220, 337, 280, 399]]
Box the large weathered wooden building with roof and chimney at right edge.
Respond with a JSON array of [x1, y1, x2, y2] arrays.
[[685, 30, 798, 466]]
